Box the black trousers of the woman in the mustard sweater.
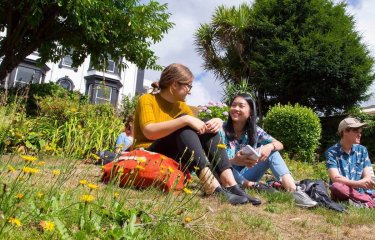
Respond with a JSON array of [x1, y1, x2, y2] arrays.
[[147, 127, 232, 176]]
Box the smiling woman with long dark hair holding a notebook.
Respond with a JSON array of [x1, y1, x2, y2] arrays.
[[220, 93, 317, 207]]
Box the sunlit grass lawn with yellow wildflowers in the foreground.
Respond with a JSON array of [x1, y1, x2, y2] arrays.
[[0, 156, 375, 240]]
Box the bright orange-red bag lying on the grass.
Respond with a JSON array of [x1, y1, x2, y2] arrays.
[[102, 150, 190, 192]]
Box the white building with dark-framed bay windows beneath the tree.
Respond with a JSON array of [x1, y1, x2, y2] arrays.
[[1, 52, 145, 105]]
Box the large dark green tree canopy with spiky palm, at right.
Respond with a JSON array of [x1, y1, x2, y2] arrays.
[[196, 0, 375, 115]]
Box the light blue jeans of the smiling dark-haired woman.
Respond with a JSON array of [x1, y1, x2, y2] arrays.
[[233, 152, 290, 185]]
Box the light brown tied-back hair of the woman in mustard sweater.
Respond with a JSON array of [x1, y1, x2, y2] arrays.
[[151, 63, 194, 92]]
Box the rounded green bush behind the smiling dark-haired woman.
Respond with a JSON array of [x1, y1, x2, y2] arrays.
[[263, 104, 322, 162]]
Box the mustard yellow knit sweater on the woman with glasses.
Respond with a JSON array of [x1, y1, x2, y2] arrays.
[[134, 93, 193, 148]]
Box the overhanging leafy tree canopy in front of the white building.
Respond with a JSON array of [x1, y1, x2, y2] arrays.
[[0, 0, 173, 82]]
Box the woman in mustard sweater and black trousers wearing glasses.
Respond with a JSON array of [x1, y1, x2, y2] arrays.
[[134, 63, 261, 205]]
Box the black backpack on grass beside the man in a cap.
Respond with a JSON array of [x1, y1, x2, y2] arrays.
[[298, 179, 345, 212]]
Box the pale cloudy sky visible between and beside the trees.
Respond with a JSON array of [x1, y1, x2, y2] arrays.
[[145, 0, 375, 106]]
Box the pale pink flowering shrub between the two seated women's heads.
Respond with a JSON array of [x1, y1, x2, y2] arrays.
[[198, 102, 229, 121]]
